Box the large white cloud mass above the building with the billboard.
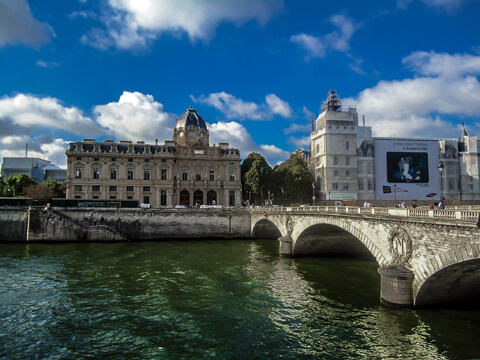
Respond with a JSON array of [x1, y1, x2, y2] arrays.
[[343, 52, 480, 137]]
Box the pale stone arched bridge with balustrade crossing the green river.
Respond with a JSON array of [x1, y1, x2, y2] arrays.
[[251, 206, 480, 306]]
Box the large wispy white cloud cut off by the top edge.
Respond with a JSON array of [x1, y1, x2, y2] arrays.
[[82, 0, 284, 49]]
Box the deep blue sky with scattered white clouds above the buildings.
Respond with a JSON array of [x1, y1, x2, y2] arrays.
[[0, 0, 480, 165]]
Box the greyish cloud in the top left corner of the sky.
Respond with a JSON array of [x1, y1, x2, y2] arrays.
[[0, 0, 54, 47]]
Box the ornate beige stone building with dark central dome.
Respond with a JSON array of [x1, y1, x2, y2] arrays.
[[66, 106, 241, 207]]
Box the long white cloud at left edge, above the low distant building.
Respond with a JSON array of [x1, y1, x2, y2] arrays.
[[0, 94, 102, 134]]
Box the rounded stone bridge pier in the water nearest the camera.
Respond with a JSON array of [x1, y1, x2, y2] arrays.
[[378, 265, 414, 307]]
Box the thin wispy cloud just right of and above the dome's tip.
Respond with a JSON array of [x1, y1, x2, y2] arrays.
[[190, 91, 293, 120]]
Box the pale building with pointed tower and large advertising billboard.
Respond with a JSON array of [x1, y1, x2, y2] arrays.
[[310, 90, 480, 201]]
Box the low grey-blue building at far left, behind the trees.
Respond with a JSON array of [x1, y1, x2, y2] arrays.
[[1, 157, 67, 183]]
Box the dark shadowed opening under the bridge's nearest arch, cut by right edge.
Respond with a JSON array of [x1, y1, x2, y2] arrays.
[[415, 258, 480, 308]]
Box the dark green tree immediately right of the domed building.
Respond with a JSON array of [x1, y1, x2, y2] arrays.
[[242, 153, 274, 205]]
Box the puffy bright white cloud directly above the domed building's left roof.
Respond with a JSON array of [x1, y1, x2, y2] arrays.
[[94, 91, 175, 142]]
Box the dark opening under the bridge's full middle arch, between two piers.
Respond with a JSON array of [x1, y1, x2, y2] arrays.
[[292, 223, 376, 261]]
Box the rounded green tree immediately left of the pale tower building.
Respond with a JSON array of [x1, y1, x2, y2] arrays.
[[275, 154, 313, 204]]
